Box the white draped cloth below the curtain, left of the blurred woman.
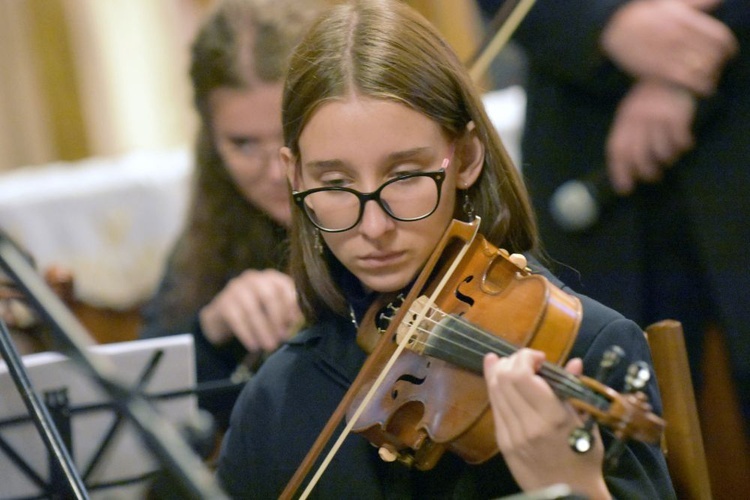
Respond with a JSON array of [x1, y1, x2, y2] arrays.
[[0, 149, 192, 309]]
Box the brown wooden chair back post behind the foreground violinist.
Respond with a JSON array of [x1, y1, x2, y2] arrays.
[[646, 319, 712, 500]]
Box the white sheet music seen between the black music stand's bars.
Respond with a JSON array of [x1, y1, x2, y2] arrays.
[[0, 334, 197, 499]]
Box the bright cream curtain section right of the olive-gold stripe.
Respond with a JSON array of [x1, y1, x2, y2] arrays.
[[65, 0, 200, 155]]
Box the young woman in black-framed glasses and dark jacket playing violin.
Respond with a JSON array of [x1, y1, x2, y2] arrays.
[[217, 1, 674, 498]]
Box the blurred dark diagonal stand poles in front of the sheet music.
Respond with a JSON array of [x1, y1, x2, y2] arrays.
[[0, 230, 226, 499]]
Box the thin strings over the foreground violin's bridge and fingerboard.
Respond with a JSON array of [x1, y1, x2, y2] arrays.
[[400, 306, 597, 400]]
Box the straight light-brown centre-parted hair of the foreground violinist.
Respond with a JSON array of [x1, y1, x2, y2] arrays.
[[282, 0, 538, 321]]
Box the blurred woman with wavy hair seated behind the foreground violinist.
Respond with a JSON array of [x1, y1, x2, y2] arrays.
[[140, 0, 321, 427]]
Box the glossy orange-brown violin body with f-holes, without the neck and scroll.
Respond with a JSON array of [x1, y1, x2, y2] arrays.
[[348, 221, 582, 470]]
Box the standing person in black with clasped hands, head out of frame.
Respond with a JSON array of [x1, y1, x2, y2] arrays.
[[515, 0, 750, 436]]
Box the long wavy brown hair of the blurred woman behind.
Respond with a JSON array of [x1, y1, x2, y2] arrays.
[[162, 0, 321, 322]]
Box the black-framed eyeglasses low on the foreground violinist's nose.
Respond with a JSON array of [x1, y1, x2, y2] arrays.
[[292, 168, 445, 233]]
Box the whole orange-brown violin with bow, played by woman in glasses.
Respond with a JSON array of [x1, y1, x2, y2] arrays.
[[282, 217, 665, 497]]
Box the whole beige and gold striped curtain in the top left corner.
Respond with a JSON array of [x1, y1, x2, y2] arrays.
[[0, 0, 210, 170]]
